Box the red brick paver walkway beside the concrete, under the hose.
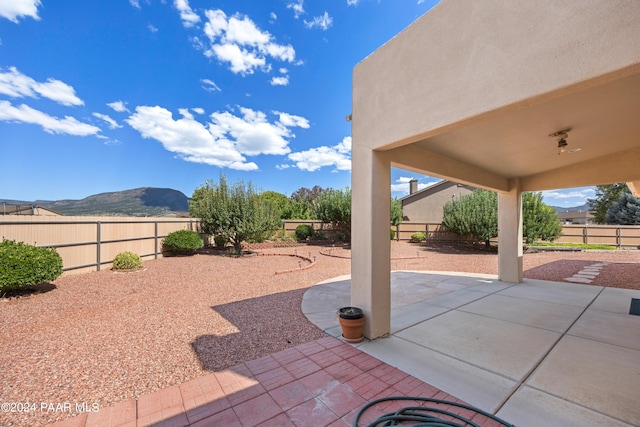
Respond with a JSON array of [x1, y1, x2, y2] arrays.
[[47, 337, 510, 427]]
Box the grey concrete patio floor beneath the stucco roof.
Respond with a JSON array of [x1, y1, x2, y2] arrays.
[[303, 271, 640, 427]]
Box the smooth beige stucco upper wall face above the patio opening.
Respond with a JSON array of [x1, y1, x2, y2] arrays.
[[353, 0, 640, 152]]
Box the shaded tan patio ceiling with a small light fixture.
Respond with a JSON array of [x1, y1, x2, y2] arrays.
[[396, 69, 640, 190]]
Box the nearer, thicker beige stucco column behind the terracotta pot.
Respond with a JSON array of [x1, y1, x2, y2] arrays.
[[351, 144, 391, 339]]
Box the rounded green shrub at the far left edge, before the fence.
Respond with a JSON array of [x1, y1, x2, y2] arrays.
[[0, 240, 62, 291]]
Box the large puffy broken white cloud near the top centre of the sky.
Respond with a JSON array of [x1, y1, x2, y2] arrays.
[[204, 10, 295, 75]]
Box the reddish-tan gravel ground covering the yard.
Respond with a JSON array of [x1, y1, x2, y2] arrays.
[[0, 242, 640, 426]]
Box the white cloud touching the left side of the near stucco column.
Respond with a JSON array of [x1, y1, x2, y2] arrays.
[[286, 136, 351, 172]]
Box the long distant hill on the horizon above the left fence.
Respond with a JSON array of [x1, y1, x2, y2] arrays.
[[0, 187, 189, 216]]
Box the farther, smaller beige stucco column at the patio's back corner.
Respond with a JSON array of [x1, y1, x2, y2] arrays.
[[498, 180, 522, 283]]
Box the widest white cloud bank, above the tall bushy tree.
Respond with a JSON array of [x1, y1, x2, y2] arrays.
[[126, 106, 308, 170]]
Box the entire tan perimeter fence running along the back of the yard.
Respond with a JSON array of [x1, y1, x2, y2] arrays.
[[0, 215, 640, 273]]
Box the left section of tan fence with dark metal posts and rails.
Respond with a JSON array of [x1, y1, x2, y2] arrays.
[[0, 215, 200, 272]]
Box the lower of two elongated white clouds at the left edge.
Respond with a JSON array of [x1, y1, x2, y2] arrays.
[[0, 101, 100, 136]]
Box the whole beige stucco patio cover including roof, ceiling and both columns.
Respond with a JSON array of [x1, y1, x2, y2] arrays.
[[352, 0, 640, 337]]
